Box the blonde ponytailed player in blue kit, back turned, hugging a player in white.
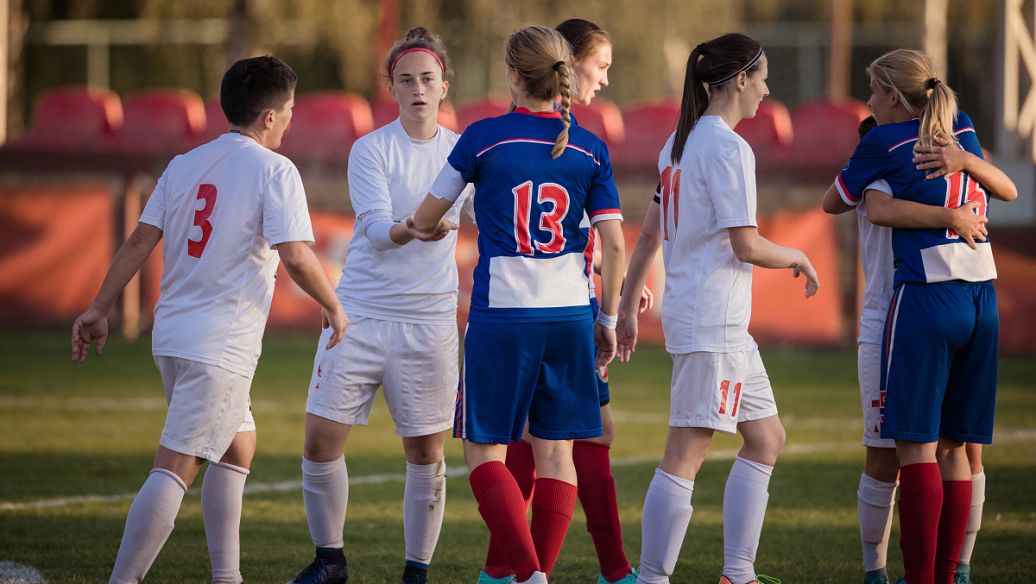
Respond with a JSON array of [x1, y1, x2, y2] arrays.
[[833, 50, 1017, 584]]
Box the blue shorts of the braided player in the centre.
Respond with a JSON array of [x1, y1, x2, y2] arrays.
[[454, 318, 603, 444]]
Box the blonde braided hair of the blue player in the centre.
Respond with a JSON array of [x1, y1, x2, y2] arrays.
[[503, 26, 573, 158]]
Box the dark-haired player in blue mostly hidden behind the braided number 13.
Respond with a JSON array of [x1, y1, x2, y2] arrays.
[[479, 19, 654, 584]]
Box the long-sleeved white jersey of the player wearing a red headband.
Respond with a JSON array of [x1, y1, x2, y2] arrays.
[[338, 119, 470, 323]]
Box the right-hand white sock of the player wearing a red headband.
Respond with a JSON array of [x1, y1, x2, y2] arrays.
[[403, 461, 447, 565]]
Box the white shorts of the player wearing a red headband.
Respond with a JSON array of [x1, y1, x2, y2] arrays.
[[306, 316, 458, 437]]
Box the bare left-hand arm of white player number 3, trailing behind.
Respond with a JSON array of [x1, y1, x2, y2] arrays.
[[71, 223, 162, 362]]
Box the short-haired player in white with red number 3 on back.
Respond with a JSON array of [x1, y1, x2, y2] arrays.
[[73, 57, 347, 584]]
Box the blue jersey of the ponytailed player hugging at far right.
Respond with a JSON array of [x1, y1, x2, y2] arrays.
[[835, 112, 997, 286]]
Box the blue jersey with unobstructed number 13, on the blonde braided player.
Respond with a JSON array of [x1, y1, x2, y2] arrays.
[[432, 108, 622, 322]]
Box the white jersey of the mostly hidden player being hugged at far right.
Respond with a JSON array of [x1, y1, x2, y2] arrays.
[[856, 179, 895, 344]]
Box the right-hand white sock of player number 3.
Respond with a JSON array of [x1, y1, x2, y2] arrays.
[[201, 462, 249, 584]]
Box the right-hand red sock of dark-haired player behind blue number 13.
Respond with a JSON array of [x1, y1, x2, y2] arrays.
[[572, 440, 632, 582]]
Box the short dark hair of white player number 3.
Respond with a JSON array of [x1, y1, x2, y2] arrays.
[[220, 55, 298, 126]]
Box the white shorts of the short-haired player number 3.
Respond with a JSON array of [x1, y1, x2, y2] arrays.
[[154, 355, 256, 462]]
